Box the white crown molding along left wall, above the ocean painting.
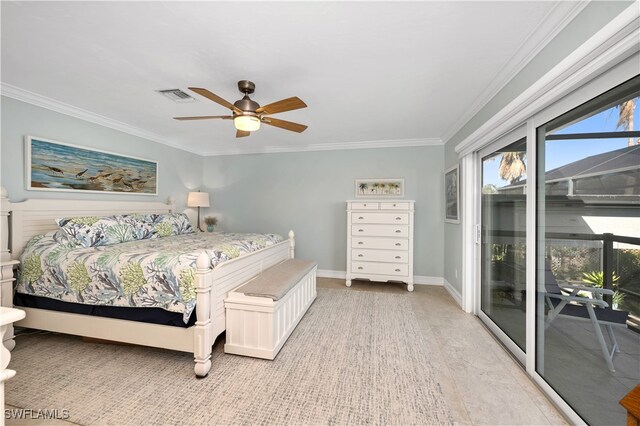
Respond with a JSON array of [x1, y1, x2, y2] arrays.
[[0, 82, 202, 155]]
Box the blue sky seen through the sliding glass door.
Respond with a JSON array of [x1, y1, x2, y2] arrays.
[[483, 101, 640, 188]]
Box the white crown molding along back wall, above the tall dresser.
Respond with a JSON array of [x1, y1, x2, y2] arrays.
[[202, 138, 444, 157]]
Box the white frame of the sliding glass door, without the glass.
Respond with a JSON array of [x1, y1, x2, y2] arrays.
[[457, 35, 640, 424]]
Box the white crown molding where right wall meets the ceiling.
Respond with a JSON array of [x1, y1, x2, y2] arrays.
[[442, 0, 591, 141]]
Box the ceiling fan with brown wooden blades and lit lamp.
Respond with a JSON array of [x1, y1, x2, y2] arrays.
[[173, 80, 307, 138]]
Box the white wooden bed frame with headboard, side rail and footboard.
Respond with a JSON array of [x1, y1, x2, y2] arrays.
[[0, 190, 295, 377]]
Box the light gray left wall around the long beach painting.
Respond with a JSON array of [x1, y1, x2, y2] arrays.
[[0, 96, 203, 211]]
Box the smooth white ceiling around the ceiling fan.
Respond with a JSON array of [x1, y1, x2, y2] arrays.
[[1, 1, 583, 155]]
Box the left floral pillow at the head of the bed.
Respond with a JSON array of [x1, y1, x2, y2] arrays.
[[56, 216, 136, 247]]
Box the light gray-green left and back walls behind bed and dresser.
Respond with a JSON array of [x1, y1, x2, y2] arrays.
[[0, 97, 444, 277]]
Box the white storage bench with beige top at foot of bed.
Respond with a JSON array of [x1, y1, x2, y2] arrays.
[[224, 259, 318, 359]]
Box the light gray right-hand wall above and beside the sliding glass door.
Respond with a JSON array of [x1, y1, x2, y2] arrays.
[[443, 1, 633, 291]]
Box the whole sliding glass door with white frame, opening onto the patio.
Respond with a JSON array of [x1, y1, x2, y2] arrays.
[[464, 29, 640, 425]]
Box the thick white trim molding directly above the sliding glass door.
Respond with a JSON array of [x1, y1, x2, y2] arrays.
[[455, 2, 640, 157]]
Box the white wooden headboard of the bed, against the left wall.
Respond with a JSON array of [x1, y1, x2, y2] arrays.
[[0, 188, 175, 261]]
